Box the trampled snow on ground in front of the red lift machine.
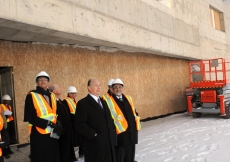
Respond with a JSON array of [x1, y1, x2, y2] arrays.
[[135, 113, 230, 162]]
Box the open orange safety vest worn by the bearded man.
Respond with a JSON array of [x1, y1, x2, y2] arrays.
[[102, 93, 141, 134]]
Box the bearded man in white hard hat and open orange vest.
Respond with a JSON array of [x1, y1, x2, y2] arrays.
[[103, 78, 141, 162]]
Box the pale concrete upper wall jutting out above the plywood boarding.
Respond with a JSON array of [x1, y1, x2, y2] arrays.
[[0, 0, 230, 59]]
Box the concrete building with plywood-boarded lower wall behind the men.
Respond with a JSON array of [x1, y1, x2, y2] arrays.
[[0, 0, 230, 143]]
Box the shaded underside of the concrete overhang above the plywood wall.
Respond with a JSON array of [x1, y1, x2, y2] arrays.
[[0, 18, 194, 59]]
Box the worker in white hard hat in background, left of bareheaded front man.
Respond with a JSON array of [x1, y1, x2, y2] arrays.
[[63, 86, 84, 157]]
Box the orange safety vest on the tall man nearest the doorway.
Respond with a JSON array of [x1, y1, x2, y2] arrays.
[[29, 92, 57, 134]]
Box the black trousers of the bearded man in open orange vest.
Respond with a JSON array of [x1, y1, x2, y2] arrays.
[[115, 144, 135, 162]]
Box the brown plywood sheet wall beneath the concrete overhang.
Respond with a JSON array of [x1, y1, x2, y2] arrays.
[[0, 41, 189, 143]]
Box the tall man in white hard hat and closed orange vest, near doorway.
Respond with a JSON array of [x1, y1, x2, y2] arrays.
[[24, 71, 63, 162]]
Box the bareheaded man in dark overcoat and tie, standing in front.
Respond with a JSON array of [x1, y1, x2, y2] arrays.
[[75, 79, 115, 162]]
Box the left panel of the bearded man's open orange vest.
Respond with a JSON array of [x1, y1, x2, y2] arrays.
[[102, 93, 128, 134]]
